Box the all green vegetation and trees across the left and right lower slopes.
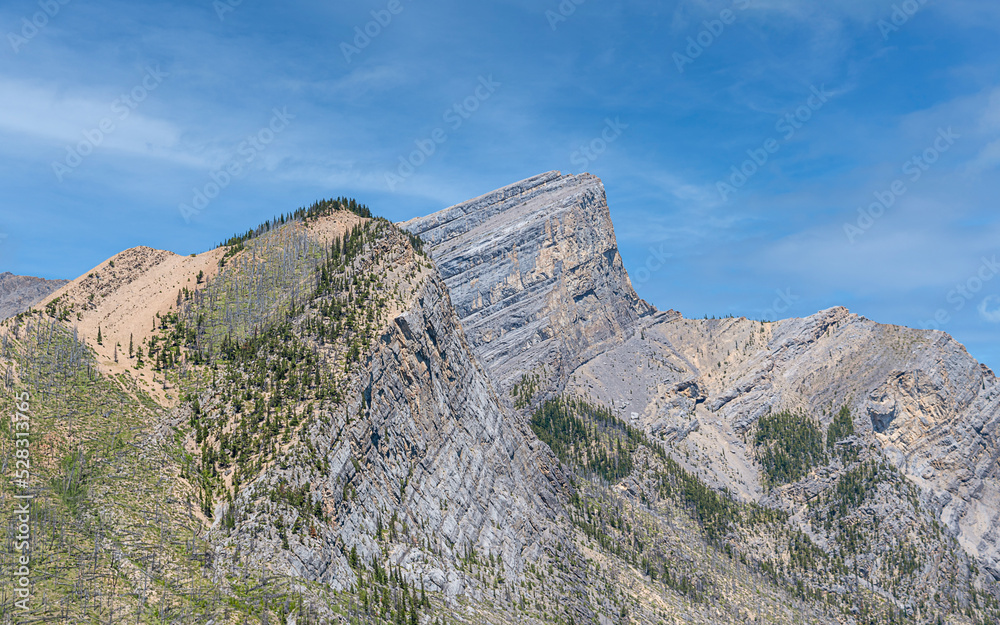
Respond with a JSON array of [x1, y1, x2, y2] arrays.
[[7, 194, 1000, 625]]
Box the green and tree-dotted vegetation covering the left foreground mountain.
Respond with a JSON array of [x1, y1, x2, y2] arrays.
[[0, 201, 458, 625]]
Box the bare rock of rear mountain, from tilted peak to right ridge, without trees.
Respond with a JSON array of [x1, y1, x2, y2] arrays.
[[403, 173, 1000, 596]]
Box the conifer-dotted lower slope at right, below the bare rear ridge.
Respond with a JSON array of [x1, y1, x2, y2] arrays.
[[514, 386, 1000, 624]]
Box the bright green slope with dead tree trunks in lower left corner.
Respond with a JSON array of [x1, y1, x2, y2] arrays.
[[0, 312, 318, 623]]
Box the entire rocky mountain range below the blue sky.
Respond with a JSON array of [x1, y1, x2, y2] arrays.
[[0, 178, 1000, 625]]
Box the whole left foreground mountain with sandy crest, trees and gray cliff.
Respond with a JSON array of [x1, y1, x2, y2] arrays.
[[0, 202, 594, 623]]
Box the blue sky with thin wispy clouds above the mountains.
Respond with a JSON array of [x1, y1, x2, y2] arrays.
[[0, 0, 1000, 368]]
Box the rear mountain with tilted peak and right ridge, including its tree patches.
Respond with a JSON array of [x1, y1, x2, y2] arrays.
[[403, 172, 1000, 614]]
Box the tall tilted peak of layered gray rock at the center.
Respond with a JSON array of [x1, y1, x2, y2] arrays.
[[401, 172, 653, 390]]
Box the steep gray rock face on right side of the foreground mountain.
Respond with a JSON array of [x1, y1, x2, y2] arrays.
[[214, 223, 565, 598]]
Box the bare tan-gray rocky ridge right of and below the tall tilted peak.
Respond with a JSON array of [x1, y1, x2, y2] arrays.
[[566, 286, 1000, 571]]
